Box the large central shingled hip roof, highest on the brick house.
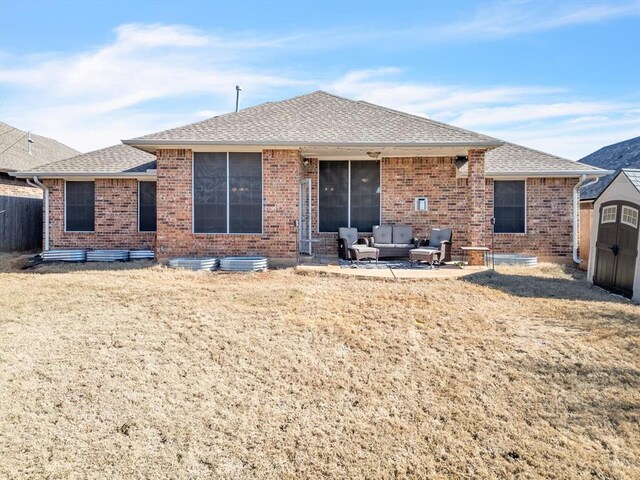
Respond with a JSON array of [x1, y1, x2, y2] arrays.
[[123, 91, 503, 146]]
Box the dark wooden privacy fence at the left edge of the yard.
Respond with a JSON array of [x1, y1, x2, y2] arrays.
[[0, 195, 42, 252]]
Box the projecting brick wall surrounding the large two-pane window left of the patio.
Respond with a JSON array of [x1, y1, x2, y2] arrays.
[[157, 150, 301, 259]]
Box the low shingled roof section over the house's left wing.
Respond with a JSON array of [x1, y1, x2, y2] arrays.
[[14, 145, 156, 176]]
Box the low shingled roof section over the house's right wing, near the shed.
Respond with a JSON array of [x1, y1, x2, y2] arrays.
[[460, 143, 603, 177]]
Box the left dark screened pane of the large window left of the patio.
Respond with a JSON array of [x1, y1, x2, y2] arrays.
[[193, 153, 227, 233]]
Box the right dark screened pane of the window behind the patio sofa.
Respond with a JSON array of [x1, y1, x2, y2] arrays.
[[351, 161, 380, 232]]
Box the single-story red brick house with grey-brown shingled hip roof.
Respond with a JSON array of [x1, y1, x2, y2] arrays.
[[11, 92, 608, 262]]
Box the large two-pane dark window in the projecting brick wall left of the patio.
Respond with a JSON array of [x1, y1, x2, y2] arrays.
[[193, 152, 262, 233]]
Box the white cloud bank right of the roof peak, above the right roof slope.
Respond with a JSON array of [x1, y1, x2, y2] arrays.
[[326, 68, 640, 159]]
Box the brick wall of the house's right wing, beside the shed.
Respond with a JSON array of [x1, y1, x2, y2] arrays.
[[485, 178, 578, 261]]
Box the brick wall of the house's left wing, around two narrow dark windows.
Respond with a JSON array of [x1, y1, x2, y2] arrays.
[[43, 179, 155, 249]]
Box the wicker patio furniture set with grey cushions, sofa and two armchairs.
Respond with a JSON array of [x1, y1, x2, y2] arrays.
[[338, 225, 453, 268]]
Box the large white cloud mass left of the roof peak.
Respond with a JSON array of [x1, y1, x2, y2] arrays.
[[0, 24, 312, 150]]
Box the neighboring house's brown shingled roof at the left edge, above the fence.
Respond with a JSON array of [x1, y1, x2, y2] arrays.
[[0, 122, 80, 172]]
